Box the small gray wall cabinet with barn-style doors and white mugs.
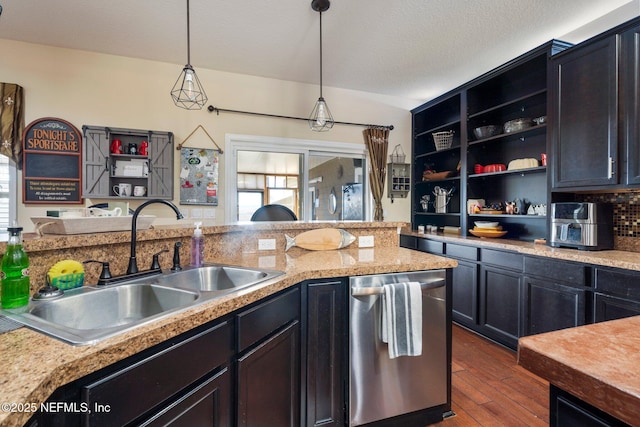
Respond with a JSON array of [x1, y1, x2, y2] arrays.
[[82, 125, 174, 199]]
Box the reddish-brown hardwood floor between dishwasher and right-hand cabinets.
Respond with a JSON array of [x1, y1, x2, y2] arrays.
[[433, 325, 549, 427]]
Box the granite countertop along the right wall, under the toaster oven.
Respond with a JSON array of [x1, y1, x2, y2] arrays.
[[402, 230, 640, 271]]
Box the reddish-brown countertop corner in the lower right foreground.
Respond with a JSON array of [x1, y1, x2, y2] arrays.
[[518, 316, 640, 425]]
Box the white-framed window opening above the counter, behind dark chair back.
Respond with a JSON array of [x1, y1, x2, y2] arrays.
[[225, 135, 370, 221]]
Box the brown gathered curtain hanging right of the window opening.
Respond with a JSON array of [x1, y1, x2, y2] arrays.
[[362, 128, 389, 221]]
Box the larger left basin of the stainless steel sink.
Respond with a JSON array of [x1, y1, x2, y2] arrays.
[[2, 283, 200, 345]]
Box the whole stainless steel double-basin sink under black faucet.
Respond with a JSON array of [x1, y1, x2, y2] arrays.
[[2, 264, 283, 345]]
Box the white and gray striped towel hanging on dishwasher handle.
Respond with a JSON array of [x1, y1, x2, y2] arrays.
[[381, 282, 422, 359]]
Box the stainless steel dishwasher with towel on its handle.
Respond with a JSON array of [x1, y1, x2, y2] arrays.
[[349, 270, 451, 426]]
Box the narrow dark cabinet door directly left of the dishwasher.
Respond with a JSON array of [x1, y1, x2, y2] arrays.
[[305, 280, 348, 426]]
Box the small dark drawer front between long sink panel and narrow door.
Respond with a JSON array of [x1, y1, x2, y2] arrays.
[[238, 287, 300, 351]]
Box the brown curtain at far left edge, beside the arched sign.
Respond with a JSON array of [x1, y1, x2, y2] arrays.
[[0, 83, 24, 170]]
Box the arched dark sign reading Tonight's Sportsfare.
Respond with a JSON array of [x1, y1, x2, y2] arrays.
[[22, 117, 82, 204]]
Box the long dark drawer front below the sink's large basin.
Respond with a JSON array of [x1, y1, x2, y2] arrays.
[[81, 322, 232, 426]]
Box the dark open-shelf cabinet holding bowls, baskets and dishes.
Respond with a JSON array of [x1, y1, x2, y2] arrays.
[[412, 41, 569, 240]]
